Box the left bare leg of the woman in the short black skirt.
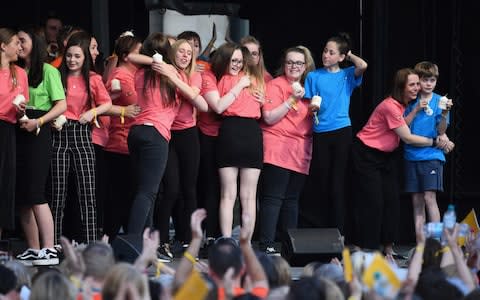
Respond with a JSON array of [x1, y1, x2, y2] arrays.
[[218, 167, 238, 237]]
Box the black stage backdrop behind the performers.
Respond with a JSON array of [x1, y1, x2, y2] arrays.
[[0, 0, 480, 242]]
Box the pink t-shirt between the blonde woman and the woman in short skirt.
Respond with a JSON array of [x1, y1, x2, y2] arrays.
[[197, 70, 221, 136]]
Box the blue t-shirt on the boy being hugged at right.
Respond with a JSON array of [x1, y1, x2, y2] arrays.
[[404, 93, 450, 162]]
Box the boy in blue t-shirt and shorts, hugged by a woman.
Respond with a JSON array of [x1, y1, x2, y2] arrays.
[[404, 61, 454, 239]]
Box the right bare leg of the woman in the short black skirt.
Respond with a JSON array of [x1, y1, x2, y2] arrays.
[[240, 168, 260, 240]]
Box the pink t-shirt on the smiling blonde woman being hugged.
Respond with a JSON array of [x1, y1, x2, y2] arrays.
[[172, 72, 202, 130]]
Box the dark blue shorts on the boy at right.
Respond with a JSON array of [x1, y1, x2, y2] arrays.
[[405, 160, 443, 193]]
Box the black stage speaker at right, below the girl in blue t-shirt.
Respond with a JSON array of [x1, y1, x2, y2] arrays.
[[283, 228, 344, 267]]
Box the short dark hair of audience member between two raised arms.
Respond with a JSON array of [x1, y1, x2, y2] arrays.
[[208, 238, 243, 278]]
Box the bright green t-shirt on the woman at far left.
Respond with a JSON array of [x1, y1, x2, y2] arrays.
[[28, 64, 65, 111]]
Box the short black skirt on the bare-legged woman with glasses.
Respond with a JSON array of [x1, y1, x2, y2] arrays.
[[217, 117, 263, 169]]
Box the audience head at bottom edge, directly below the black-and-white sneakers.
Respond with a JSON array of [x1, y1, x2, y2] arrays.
[[29, 269, 76, 300]]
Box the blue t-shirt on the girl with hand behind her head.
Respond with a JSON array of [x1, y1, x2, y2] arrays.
[[305, 66, 363, 132]]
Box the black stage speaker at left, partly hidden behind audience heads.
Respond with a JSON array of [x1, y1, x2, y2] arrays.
[[111, 234, 143, 263]]
